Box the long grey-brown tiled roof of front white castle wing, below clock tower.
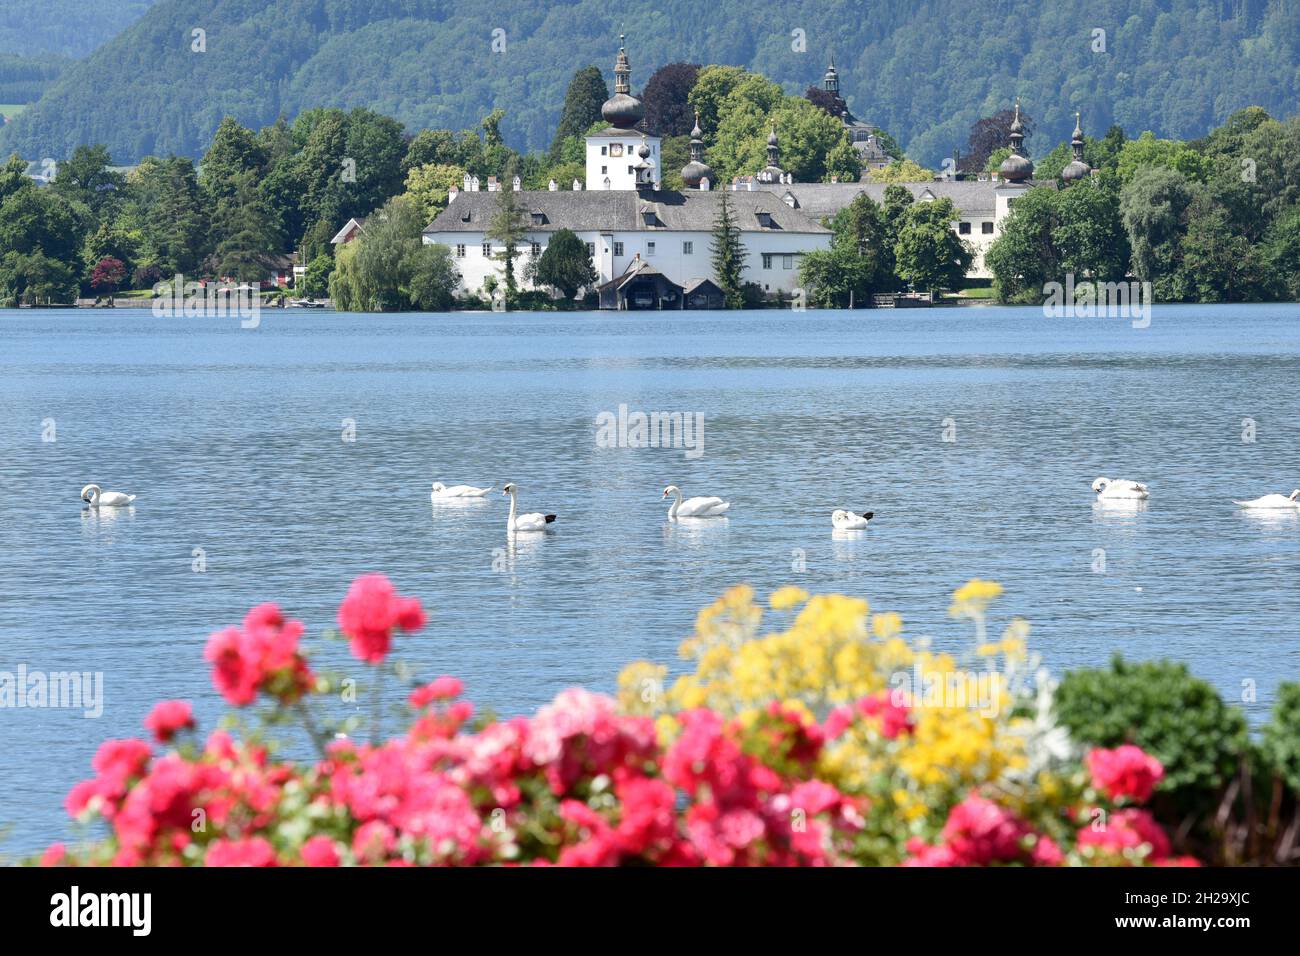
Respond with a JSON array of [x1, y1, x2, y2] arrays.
[[424, 187, 828, 235]]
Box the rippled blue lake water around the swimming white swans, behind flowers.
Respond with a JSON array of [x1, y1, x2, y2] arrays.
[[0, 306, 1300, 855]]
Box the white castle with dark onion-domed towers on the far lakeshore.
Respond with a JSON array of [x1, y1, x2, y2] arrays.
[[424, 38, 1050, 303]]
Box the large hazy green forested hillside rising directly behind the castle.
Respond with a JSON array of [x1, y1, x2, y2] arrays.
[[0, 0, 1300, 165]]
